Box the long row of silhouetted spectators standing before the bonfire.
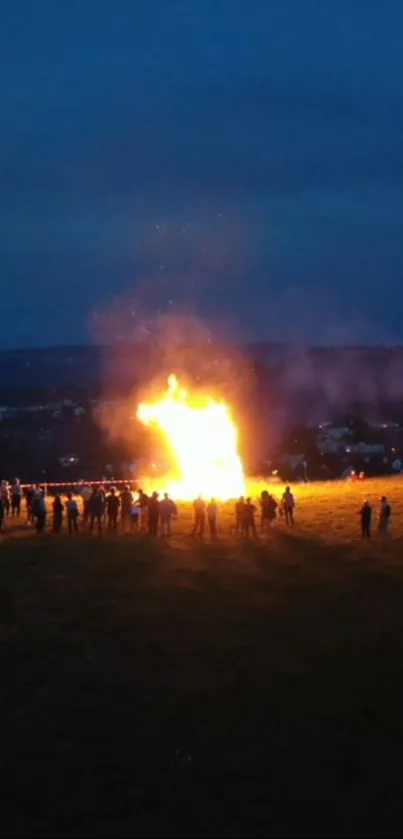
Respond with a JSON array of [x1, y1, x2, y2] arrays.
[[0, 478, 295, 537]]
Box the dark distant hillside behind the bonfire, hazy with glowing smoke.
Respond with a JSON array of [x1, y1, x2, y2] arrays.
[[0, 343, 403, 480]]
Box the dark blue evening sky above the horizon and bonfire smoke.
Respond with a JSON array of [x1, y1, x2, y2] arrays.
[[0, 0, 403, 346]]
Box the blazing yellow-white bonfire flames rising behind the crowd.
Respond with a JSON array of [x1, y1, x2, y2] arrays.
[[137, 375, 245, 501]]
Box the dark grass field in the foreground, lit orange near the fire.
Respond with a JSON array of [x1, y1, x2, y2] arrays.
[[0, 479, 403, 837]]
